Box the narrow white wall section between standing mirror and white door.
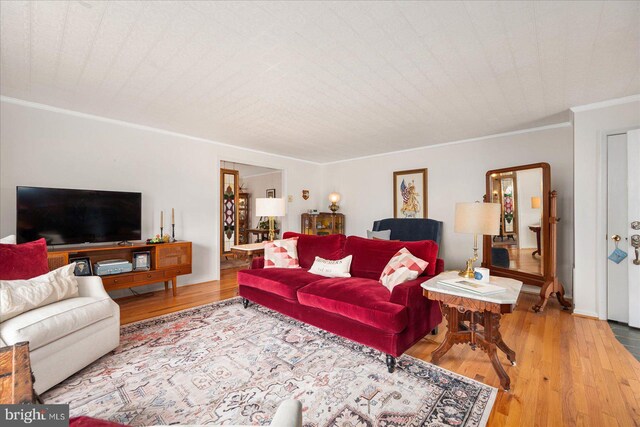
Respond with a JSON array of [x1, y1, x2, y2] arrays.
[[573, 96, 640, 319]]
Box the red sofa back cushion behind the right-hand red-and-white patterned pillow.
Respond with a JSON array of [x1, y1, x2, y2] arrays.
[[344, 236, 438, 280]]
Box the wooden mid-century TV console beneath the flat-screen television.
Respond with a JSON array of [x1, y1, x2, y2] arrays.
[[47, 241, 191, 296]]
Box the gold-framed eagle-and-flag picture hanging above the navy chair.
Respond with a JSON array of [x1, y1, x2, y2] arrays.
[[393, 168, 429, 218]]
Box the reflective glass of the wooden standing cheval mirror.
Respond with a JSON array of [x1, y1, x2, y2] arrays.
[[490, 168, 544, 275]]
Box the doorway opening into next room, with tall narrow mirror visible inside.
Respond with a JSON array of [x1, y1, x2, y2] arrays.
[[220, 160, 284, 271]]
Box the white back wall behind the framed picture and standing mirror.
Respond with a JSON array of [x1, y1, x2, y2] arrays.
[[324, 124, 573, 295]]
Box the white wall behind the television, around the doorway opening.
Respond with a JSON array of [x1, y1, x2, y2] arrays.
[[0, 98, 321, 291]]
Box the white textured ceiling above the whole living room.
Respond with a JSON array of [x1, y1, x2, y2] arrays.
[[0, 1, 640, 162]]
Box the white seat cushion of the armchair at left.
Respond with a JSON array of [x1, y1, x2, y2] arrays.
[[0, 297, 113, 351]]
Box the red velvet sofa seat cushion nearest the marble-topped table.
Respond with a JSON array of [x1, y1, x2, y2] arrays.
[[298, 277, 409, 333]]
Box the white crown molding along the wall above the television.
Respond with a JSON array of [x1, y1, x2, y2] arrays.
[[0, 95, 322, 166]]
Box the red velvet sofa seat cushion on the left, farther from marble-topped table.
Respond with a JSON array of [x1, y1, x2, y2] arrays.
[[238, 268, 322, 301]]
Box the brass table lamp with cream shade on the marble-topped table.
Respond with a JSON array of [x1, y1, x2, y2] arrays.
[[454, 202, 501, 279]]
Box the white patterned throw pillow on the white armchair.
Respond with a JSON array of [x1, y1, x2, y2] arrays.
[[0, 262, 78, 322]]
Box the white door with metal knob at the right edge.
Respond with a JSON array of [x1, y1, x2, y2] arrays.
[[607, 130, 640, 327]]
